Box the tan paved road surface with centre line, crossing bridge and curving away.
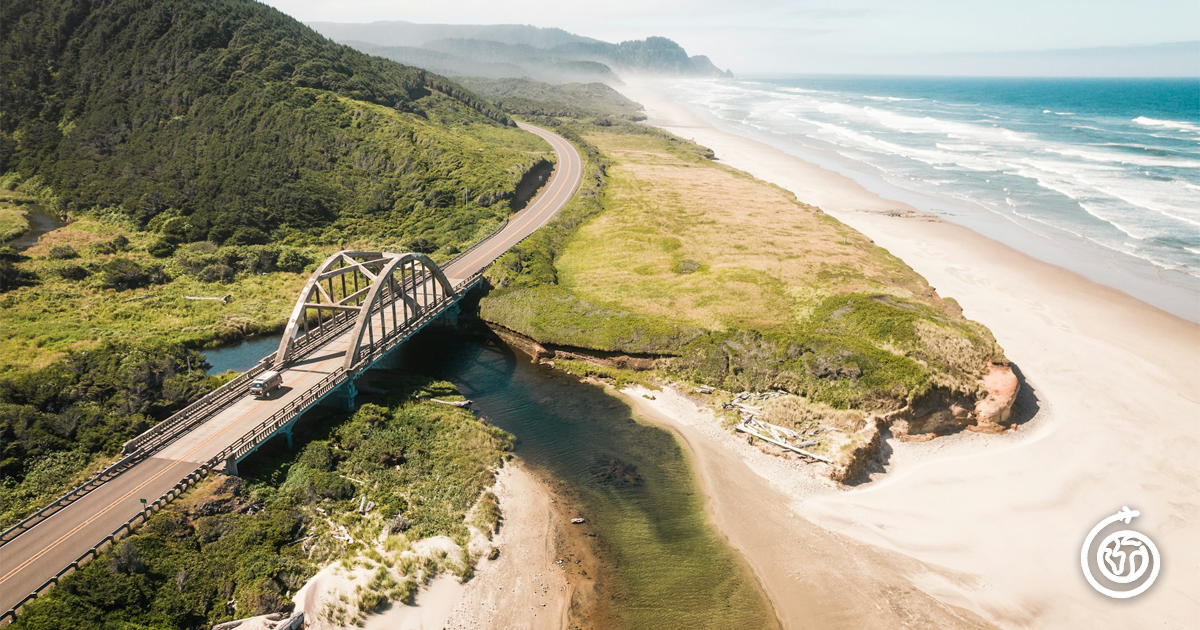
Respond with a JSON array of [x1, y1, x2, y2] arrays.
[[0, 124, 583, 612]]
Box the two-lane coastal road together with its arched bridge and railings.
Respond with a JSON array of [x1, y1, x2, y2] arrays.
[[0, 122, 584, 625]]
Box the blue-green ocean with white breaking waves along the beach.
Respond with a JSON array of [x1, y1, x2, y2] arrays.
[[671, 77, 1200, 320]]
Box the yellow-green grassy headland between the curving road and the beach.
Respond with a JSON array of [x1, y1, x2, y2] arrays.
[[481, 125, 1004, 453]]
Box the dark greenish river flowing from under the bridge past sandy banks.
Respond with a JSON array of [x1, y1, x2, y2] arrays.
[[394, 331, 778, 629]]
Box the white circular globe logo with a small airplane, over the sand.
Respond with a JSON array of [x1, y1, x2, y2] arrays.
[[1079, 508, 1162, 599]]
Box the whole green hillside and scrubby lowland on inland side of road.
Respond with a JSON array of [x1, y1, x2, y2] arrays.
[[0, 0, 550, 540]]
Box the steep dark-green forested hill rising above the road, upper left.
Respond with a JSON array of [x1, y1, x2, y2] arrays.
[[0, 0, 549, 244]]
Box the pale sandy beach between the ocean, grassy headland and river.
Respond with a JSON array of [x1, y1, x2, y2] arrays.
[[620, 79, 1200, 628]]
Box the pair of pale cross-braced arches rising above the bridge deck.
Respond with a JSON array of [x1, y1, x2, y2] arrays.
[[275, 250, 457, 371]]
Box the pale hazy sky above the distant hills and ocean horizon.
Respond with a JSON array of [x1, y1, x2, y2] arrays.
[[266, 0, 1200, 73]]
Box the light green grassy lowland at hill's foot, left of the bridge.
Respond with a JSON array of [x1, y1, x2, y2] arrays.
[[0, 218, 304, 373]]
